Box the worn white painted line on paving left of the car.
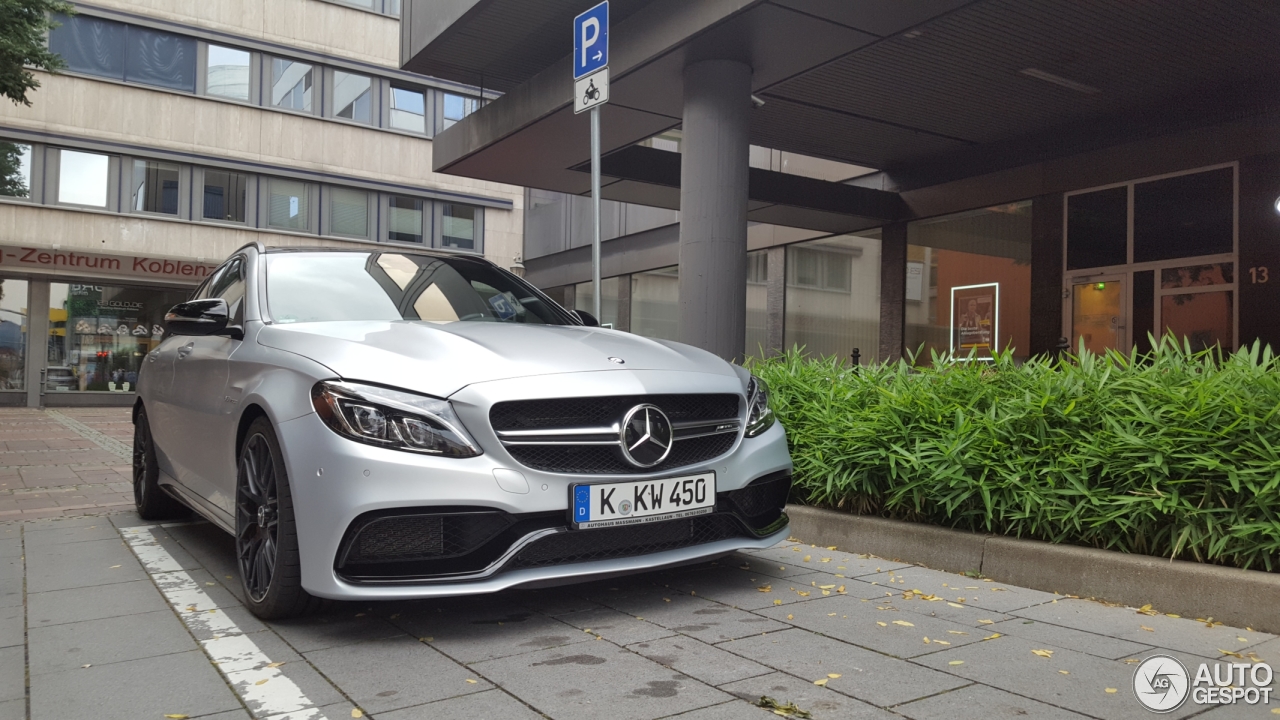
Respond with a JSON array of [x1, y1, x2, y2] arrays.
[[120, 525, 325, 720]]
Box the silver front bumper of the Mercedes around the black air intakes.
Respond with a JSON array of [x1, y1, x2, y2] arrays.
[[276, 404, 791, 600]]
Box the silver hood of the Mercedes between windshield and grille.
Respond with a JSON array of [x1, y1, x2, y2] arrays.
[[257, 320, 736, 397]]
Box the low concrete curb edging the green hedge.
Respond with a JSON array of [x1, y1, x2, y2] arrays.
[[787, 505, 1280, 633]]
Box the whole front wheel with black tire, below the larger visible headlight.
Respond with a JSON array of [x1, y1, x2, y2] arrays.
[[236, 418, 320, 620]]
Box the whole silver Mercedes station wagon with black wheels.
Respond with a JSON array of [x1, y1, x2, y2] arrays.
[[133, 245, 791, 618]]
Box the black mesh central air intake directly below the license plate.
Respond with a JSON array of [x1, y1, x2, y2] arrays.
[[507, 512, 750, 569]]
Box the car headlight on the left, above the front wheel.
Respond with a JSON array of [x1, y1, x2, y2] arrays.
[[311, 380, 480, 457]]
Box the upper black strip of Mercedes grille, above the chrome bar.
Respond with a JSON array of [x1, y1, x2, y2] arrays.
[[489, 393, 739, 430]]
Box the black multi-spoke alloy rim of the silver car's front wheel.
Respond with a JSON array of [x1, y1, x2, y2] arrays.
[[236, 434, 280, 602]]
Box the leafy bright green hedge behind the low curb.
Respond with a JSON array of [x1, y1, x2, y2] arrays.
[[751, 341, 1280, 571]]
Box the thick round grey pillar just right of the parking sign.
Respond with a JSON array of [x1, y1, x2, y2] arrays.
[[680, 60, 751, 361]]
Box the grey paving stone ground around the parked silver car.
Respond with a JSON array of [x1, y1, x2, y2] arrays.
[[0, 410, 1280, 720]]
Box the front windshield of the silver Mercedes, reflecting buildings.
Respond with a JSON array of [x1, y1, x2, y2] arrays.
[[266, 252, 576, 325]]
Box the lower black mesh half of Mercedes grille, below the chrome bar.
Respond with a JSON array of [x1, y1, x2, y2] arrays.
[[507, 433, 737, 475]]
